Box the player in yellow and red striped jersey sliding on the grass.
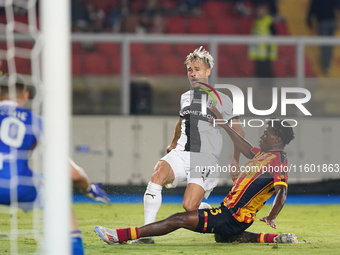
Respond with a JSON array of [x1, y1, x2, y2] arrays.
[[94, 107, 297, 244]]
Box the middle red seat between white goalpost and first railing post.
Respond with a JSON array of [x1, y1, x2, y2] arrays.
[[85, 53, 110, 75]]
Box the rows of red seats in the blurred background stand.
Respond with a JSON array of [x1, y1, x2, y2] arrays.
[[0, 0, 315, 77]]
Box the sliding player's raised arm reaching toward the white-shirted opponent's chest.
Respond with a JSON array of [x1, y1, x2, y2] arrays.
[[210, 106, 253, 159]]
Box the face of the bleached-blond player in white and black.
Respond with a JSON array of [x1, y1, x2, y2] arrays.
[[187, 61, 210, 88]]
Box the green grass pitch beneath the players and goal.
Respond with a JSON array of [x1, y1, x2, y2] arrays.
[[0, 204, 340, 255]]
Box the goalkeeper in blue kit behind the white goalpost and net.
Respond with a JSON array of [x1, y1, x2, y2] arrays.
[[0, 74, 109, 255]]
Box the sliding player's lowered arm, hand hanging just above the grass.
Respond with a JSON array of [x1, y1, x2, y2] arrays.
[[260, 185, 287, 229]]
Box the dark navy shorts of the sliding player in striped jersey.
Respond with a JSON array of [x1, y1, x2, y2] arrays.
[[195, 206, 252, 238]]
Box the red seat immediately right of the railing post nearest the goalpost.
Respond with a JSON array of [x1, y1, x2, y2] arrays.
[[133, 54, 159, 74]]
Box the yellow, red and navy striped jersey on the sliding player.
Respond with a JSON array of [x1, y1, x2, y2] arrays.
[[223, 148, 288, 223]]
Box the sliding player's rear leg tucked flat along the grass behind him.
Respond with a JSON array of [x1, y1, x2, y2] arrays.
[[215, 231, 298, 243]]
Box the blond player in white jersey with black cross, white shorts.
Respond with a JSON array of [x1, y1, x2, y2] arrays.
[[131, 47, 244, 243]]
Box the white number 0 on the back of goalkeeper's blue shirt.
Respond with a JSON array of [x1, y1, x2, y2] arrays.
[[0, 117, 26, 148]]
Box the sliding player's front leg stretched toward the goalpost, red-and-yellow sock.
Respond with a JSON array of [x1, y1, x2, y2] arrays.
[[94, 211, 199, 244]]
